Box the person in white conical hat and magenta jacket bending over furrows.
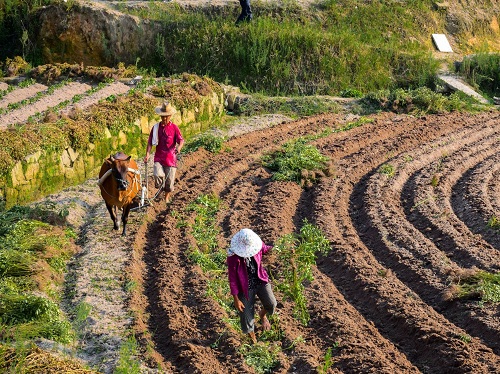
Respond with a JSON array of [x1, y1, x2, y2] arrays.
[[227, 229, 276, 343]]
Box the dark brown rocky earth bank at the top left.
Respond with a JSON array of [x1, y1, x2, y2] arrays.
[[36, 3, 161, 66]]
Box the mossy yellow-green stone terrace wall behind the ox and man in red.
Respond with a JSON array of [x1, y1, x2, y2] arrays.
[[0, 92, 224, 208]]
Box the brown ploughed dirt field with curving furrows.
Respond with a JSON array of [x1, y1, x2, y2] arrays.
[[134, 111, 500, 373]]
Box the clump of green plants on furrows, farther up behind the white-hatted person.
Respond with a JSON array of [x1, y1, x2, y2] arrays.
[[262, 138, 329, 183]]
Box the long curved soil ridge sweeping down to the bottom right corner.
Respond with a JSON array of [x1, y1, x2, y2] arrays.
[[314, 114, 499, 372]]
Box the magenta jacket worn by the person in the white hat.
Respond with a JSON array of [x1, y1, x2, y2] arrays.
[[226, 243, 272, 298]]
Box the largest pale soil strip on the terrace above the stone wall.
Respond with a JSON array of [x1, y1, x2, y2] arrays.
[[0, 82, 91, 129]]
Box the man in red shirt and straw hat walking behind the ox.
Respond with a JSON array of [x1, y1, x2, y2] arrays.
[[144, 101, 184, 204]]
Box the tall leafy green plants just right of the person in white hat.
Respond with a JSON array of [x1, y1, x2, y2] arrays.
[[273, 220, 330, 326]]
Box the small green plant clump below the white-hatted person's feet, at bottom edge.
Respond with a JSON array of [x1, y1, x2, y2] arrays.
[[240, 342, 280, 374]]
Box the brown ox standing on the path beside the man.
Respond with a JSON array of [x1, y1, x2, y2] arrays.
[[98, 152, 141, 236]]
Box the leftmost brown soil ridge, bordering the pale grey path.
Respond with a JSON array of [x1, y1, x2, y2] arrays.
[[145, 209, 231, 373]]
